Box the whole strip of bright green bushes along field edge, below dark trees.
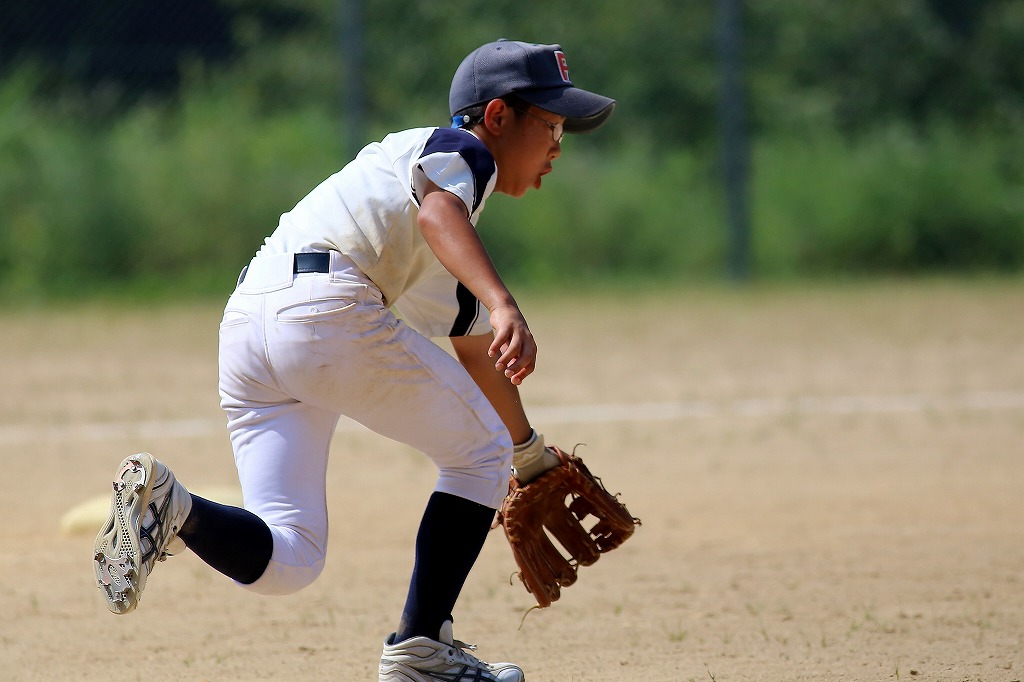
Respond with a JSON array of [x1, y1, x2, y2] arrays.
[[0, 68, 1024, 299]]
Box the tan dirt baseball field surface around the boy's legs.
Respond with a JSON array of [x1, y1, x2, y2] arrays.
[[0, 282, 1024, 682]]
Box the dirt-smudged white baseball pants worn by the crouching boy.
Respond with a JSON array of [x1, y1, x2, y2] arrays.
[[220, 252, 512, 594]]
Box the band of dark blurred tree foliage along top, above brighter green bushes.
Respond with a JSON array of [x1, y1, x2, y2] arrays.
[[0, 0, 1024, 140]]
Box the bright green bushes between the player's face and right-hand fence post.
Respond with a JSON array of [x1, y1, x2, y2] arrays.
[[481, 138, 725, 283]]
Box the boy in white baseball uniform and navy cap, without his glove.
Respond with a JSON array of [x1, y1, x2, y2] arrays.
[[94, 40, 614, 682]]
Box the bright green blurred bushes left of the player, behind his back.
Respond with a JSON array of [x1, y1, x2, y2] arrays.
[[0, 72, 341, 295]]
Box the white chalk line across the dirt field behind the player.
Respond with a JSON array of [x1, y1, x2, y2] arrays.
[[0, 391, 1024, 446]]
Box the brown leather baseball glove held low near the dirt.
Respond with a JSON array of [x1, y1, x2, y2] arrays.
[[499, 445, 640, 608]]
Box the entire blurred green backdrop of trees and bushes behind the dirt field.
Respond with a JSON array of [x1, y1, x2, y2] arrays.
[[0, 0, 1024, 293]]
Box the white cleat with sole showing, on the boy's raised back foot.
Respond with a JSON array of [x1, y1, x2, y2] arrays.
[[93, 453, 191, 614]]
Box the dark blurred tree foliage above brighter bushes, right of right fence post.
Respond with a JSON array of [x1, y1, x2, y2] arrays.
[[748, 0, 1024, 131]]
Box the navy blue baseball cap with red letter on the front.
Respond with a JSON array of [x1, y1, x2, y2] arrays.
[[449, 38, 615, 133]]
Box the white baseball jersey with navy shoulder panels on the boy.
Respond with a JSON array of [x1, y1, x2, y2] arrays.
[[260, 128, 497, 337]]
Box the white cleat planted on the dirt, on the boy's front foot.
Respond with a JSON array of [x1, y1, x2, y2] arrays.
[[378, 621, 526, 682]]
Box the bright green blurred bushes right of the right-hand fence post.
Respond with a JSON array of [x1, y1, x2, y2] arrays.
[[754, 125, 1024, 274]]
